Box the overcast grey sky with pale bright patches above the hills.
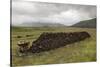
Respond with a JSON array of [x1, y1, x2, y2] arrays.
[[12, 0, 96, 26]]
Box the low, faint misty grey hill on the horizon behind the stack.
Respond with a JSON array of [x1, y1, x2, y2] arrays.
[[12, 22, 65, 27]]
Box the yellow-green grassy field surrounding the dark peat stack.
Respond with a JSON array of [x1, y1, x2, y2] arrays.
[[11, 27, 96, 66]]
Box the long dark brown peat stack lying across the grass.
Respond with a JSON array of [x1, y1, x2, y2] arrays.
[[29, 31, 90, 53]]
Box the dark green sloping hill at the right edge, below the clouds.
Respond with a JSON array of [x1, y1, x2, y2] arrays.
[[72, 18, 96, 28]]
